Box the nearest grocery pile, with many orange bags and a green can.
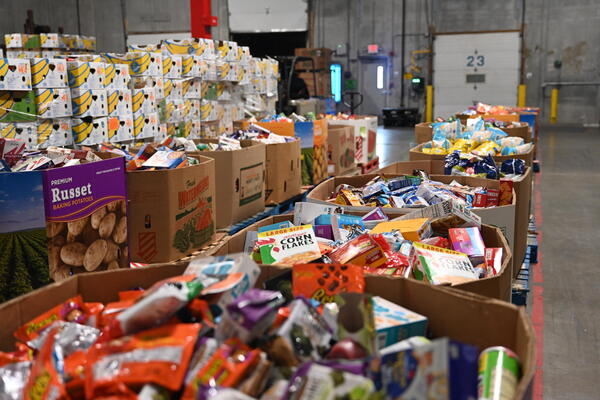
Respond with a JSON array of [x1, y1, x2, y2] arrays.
[[0, 254, 521, 400]]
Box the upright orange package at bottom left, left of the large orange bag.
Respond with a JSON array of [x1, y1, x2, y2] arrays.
[[23, 327, 67, 400]]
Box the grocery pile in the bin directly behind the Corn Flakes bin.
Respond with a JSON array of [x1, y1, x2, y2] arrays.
[[328, 172, 513, 208]]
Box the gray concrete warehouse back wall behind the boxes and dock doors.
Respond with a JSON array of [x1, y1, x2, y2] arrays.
[[0, 0, 600, 124]]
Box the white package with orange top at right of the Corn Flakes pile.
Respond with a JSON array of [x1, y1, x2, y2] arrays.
[[413, 242, 479, 285]]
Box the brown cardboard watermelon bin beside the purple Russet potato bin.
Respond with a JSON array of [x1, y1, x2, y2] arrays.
[[127, 156, 216, 263]]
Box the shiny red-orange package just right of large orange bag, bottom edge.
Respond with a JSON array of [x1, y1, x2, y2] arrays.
[[181, 339, 261, 400]]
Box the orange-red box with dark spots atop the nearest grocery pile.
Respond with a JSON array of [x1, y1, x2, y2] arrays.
[[292, 264, 365, 303]]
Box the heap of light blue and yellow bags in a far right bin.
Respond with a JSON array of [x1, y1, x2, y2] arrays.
[[421, 117, 533, 156]]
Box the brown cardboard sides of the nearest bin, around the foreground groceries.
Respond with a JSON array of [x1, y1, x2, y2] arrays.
[[0, 263, 536, 400]]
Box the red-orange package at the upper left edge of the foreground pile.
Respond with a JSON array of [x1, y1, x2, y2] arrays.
[[15, 296, 89, 343]]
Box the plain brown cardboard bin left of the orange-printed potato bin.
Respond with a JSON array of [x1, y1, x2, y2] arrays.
[[265, 140, 302, 204]]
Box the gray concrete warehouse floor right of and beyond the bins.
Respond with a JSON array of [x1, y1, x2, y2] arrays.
[[377, 128, 600, 399]]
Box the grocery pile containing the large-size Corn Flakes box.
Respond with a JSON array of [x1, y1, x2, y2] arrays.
[[244, 200, 503, 285]]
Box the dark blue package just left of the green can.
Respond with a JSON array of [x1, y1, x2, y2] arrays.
[[448, 340, 479, 400]]
